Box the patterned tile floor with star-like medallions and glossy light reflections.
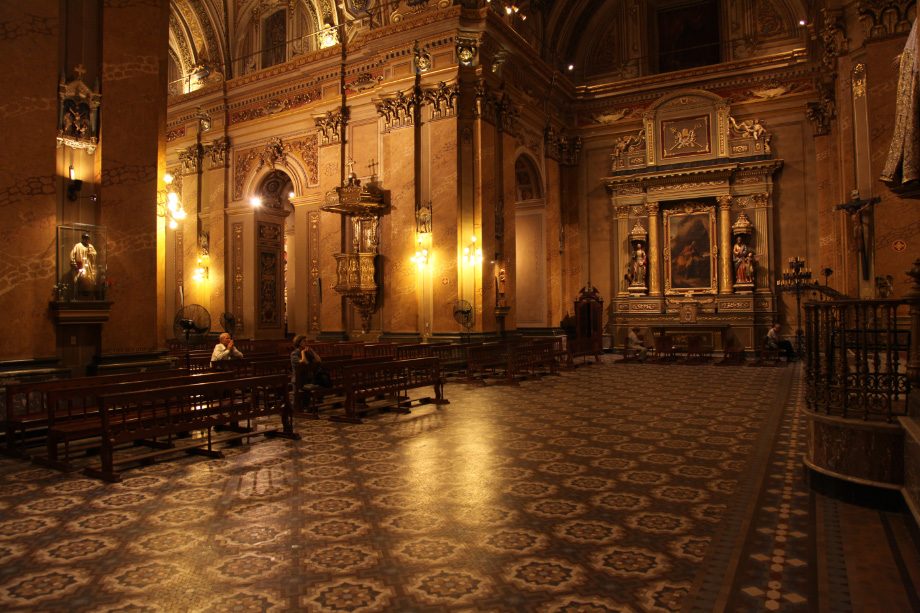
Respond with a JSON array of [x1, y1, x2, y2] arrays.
[[0, 356, 916, 613]]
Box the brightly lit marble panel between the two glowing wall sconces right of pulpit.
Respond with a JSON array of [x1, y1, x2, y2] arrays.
[[429, 118, 461, 333]]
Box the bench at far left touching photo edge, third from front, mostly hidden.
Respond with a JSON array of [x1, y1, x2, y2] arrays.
[[2, 369, 189, 459]]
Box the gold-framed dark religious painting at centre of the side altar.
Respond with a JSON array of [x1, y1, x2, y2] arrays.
[[663, 202, 719, 295]]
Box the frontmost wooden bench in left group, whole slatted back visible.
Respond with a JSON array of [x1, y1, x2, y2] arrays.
[[81, 375, 300, 483]]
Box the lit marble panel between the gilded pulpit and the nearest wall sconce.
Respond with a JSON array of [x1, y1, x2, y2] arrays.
[[380, 127, 419, 332]]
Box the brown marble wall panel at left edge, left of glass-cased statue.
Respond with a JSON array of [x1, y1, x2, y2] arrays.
[[0, 0, 60, 359]]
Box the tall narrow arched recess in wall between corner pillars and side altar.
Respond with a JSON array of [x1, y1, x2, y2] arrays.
[[514, 155, 547, 328]]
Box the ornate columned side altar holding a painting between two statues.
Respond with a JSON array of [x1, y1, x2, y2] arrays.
[[603, 90, 782, 350]]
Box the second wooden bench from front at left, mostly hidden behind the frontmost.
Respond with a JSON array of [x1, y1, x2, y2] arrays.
[[32, 373, 233, 471]]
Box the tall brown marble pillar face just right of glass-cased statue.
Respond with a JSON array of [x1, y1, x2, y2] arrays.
[[97, 3, 169, 353]]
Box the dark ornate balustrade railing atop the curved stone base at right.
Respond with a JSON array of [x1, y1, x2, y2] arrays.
[[804, 260, 920, 422]]
